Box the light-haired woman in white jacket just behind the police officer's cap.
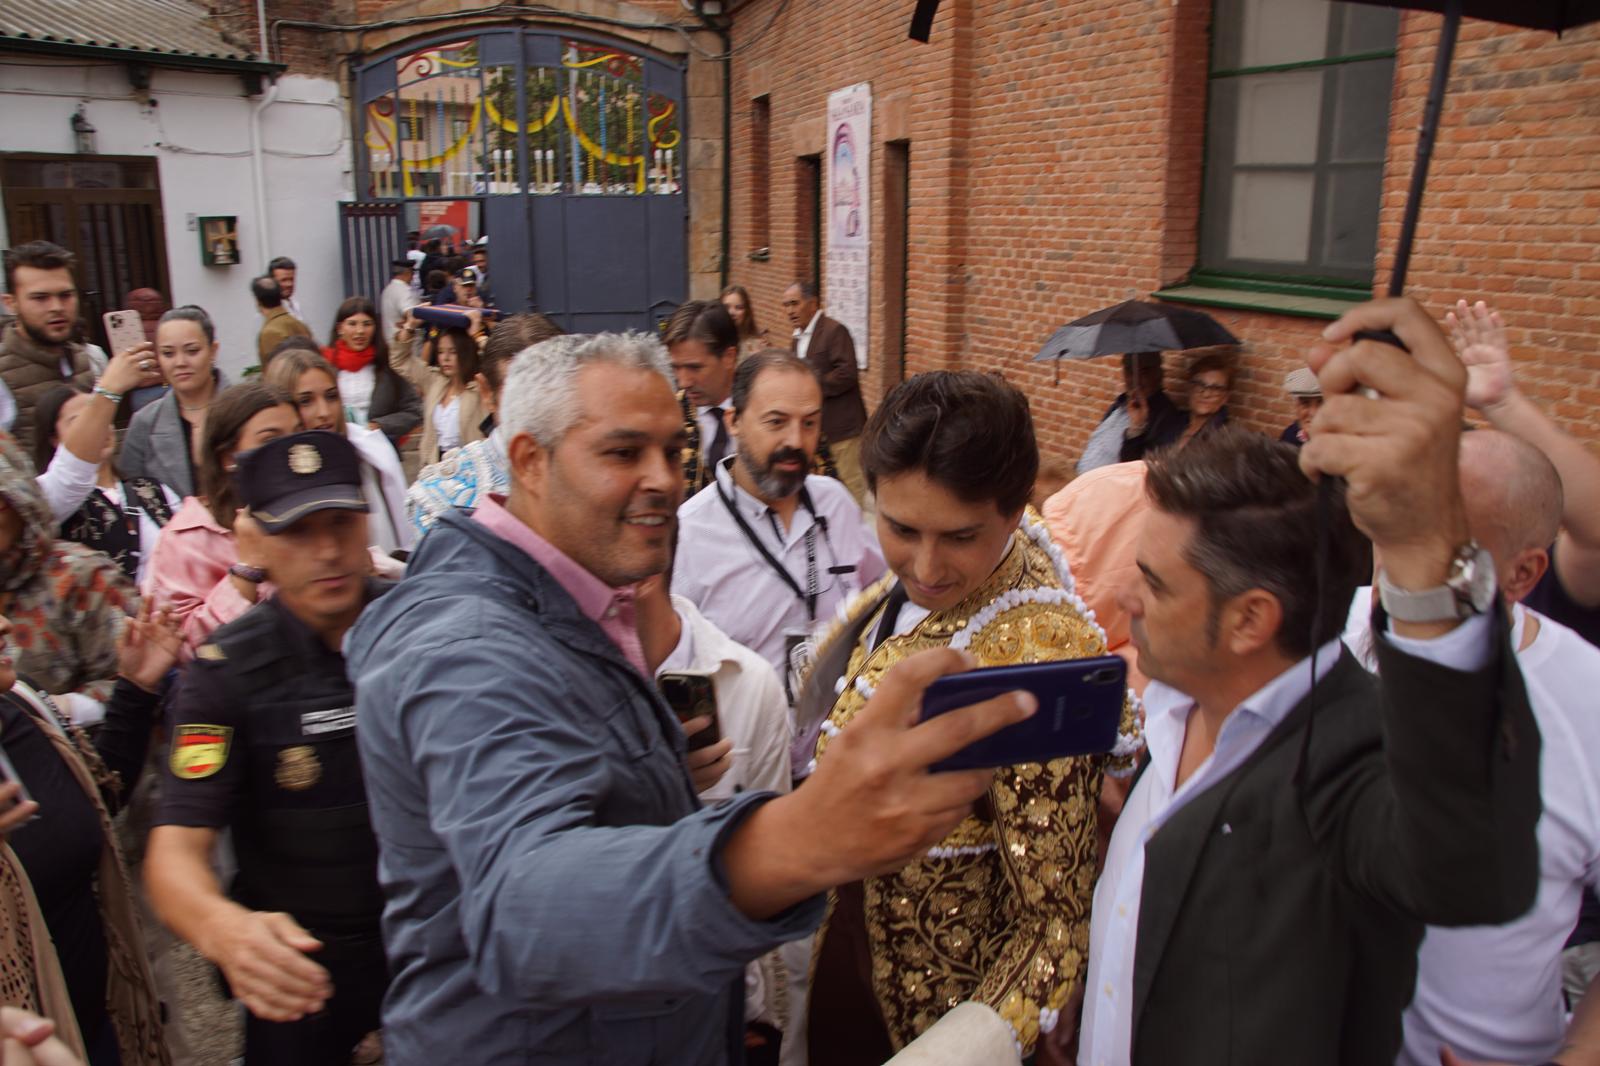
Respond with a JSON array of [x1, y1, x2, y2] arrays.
[[261, 347, 416, 552]]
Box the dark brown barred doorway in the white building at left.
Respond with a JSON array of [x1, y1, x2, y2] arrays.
[[0, 152, 173, 347]]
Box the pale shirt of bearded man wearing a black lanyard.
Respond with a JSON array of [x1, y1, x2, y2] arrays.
[[672, 461, 883, 677]]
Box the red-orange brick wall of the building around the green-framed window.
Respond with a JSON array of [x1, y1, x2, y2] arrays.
[[731, 0, 1600, 461]]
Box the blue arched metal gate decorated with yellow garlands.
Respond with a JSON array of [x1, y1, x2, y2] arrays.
[[355, 29, 688, 331]]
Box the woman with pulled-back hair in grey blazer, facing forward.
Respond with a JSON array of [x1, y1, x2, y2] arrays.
[[122, 304, 227, 496]]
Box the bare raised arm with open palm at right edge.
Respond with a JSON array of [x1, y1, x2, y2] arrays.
[[1445, 299, 1600, 607]]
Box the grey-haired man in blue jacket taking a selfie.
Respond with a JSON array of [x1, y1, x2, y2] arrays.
[[347, 333, 1035, 1066]]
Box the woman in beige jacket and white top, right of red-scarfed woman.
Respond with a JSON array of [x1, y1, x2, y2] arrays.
[[389, 312, 488, 466]]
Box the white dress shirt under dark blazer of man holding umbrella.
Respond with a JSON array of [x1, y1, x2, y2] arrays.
[[1078, 616, 1491, 1066]]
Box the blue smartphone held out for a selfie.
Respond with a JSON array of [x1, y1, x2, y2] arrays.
[[922, 655, 1128, 770]]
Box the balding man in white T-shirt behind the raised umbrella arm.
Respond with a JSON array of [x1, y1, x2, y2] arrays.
[[1346, 431, 1600, 1066]]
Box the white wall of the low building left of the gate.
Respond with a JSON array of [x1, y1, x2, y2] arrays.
[[0, 56, 350, 379]]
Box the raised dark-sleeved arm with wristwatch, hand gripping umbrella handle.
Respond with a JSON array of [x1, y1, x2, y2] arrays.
[[1301, 299, 1541, 925]]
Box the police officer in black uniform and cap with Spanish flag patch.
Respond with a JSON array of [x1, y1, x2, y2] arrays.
[[146, 431, 389, 1066]]
